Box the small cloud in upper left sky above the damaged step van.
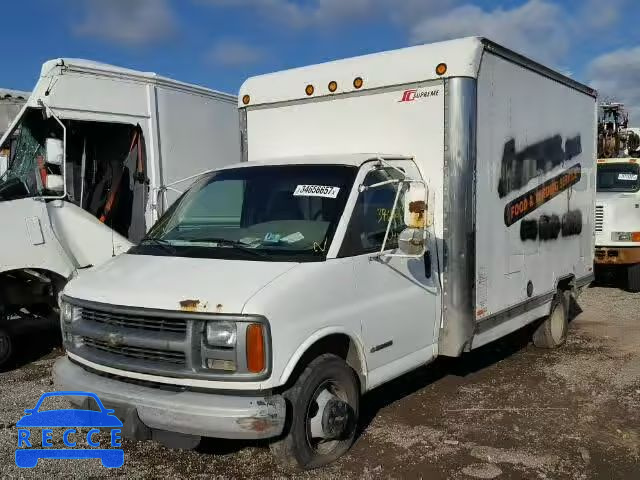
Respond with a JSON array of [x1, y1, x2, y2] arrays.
[[73, 0, 176, 46]]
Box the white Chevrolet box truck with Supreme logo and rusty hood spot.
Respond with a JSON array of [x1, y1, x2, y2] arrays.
[[54, 38, 596, 468]]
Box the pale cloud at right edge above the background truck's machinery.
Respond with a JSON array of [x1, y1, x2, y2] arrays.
[[587, 45, 640, 122]]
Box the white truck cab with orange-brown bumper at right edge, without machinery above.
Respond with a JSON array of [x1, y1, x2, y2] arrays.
[[595, 157, 640, 292]]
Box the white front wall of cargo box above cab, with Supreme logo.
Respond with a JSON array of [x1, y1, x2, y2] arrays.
[[247, 81, 444, 238]]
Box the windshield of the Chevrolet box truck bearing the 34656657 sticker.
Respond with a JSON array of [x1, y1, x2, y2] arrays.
[[129, 165, 357, 262]]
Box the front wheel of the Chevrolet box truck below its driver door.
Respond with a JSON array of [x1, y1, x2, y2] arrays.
[[271, 354, 360, 470]]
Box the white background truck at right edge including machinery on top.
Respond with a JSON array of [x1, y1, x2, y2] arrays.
[[595, 103, 640, 292]]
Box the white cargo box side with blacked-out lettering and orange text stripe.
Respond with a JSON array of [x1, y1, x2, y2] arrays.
[[476, 54, 595, 319]]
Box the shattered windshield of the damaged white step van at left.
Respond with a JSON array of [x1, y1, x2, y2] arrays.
[[0, 109, 62, 200]]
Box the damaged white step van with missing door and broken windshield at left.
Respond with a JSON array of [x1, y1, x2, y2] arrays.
[[0, 59, 241, 364]]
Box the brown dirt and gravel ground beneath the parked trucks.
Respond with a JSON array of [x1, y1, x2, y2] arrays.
[[0, 287, 640, 480]]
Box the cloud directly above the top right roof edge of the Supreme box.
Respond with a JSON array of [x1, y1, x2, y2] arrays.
[[411, 0, 571, 65]]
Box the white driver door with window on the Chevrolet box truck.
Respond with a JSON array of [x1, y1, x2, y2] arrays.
[[340, 160, 439, 387]]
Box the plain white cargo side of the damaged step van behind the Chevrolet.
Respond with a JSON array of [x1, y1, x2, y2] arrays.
[[156, 87, 240, 204]]
